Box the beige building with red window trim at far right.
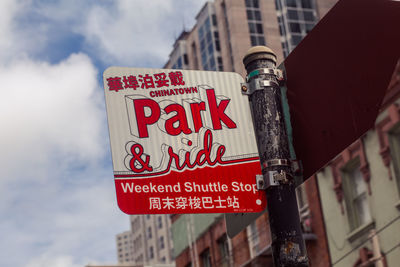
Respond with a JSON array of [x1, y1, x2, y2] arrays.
[[317, 66, 400, 267]]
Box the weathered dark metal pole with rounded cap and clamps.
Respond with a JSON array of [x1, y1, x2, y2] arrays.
[[242, 46, 308, 267]]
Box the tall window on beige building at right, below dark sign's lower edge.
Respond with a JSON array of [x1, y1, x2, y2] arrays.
[[342, 160, 371, 230]]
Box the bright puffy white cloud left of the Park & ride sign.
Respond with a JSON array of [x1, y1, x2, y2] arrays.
[[0, 54, 105, 180]]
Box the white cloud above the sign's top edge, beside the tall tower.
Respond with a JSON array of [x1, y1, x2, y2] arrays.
[[81, 0, 205, 67]]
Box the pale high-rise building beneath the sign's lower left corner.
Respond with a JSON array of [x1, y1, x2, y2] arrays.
[[116, 217, 174, 266]]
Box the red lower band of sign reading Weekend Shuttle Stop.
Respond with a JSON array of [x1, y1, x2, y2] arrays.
[[115, 161, 266, 214]]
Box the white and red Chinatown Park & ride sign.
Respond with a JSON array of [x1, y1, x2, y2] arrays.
[[104, 67, 266, 214]]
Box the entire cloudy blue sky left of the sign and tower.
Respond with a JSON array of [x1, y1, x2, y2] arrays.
[[0, 0, 205, 267]]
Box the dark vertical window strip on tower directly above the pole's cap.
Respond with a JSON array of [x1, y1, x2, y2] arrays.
[[245, 0, 265, 46]]
